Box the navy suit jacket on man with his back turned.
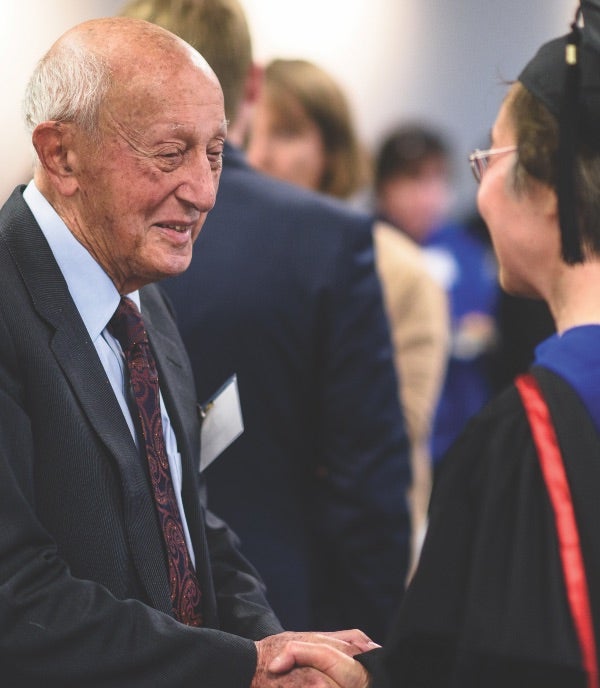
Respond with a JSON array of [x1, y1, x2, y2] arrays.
[[163, 145, 409, 637]]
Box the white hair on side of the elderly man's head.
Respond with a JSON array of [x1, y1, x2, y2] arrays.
[[23, 40, 111, 138]]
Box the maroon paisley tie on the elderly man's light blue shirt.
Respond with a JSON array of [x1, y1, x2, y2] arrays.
[[108, 297, 202, 626]]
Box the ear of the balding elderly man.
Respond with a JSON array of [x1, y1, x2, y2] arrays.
[[32, 121, 78, 196]]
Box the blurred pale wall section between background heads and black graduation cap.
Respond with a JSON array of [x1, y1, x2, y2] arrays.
[[245, 0, 578, 212]]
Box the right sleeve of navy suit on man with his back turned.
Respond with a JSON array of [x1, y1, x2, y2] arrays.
[[315, 215, 410, 640]]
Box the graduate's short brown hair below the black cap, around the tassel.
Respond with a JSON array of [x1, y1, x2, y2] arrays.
[[506, 82, 600, 254]]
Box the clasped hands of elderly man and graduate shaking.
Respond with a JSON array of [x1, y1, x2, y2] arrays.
[[250, 630, 379, 688]]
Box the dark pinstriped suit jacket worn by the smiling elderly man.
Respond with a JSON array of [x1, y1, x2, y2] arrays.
[[0, 189, 280, 688]]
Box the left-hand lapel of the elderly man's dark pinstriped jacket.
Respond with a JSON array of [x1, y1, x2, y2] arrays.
[[3, 192, 172, 614]]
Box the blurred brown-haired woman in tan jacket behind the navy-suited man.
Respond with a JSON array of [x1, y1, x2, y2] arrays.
[[247, 59, 449, 564]]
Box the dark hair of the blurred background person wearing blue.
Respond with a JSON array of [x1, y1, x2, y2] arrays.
[[375, 124, 450, 190]]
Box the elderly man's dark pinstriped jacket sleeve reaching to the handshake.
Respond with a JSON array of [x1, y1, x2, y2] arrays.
[[0, 312, 256, 688]]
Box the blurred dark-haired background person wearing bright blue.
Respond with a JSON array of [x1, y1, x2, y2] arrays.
[[375, 123, 500, 465]]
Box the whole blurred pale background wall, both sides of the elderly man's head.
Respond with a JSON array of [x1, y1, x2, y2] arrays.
[[0, 0, 576, 208]]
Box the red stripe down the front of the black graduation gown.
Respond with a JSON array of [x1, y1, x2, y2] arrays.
[[515, 374, 600, 688]]
